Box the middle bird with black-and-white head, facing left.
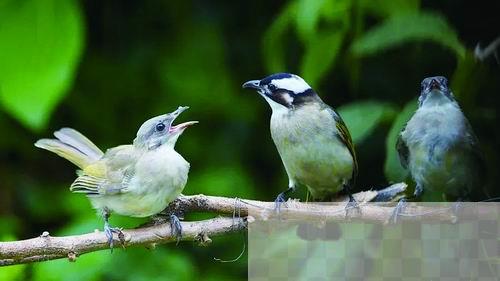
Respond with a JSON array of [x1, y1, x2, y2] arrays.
[[242, 73, 358, 211]]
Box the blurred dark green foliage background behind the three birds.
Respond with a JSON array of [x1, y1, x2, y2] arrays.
[[0, 0, 500, 280]]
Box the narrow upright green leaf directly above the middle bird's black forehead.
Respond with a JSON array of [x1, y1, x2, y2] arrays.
[[262, 2, 297, 73]]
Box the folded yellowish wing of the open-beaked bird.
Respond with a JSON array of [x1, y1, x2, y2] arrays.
[[70, 145, 137, 196]]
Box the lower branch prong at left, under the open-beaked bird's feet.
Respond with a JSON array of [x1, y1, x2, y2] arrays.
[[0, 217, 247, 266]]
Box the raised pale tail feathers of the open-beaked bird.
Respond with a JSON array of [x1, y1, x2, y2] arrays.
[[35, 128, 104, 169]]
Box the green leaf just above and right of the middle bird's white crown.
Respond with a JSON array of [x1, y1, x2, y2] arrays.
[[301, 30, 345, 87]]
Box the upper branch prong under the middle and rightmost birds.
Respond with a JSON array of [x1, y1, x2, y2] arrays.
[[170, 183, 456, 224]]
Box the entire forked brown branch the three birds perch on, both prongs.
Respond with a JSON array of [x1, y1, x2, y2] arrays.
[[0, 183, 468, 266]]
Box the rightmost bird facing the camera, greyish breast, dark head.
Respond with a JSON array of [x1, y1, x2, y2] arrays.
[[390, 76, 485, 219]]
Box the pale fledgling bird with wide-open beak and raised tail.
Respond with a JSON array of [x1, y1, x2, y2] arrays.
[[35, 106, 198, 249]]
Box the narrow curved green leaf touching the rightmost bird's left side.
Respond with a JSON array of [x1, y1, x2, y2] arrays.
[[384, 99, 417, 182]]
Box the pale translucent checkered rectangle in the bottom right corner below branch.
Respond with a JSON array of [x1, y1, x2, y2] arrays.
[[248, 203, 500, 281]]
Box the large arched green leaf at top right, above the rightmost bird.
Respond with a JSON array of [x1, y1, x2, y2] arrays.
[[352, 12, 466, 57]]
